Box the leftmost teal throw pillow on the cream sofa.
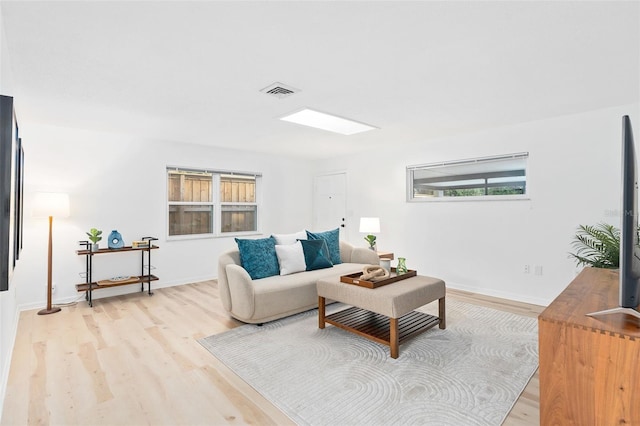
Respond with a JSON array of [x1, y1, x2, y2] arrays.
[[236, 237, 280, 280]]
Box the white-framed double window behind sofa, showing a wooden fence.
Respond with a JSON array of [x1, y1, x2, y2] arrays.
[[167, 167, 261, 237]]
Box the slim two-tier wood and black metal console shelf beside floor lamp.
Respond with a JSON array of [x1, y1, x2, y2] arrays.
[[76, 237, 159, 306]]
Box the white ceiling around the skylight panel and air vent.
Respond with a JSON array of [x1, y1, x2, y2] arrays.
[[0, 0, 640, 158]]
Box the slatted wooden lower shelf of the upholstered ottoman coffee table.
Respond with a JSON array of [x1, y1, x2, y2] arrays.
[[325, 306, 440, 346]]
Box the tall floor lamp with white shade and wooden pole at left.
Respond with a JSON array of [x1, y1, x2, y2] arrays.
[[31, 192, 69, 315]]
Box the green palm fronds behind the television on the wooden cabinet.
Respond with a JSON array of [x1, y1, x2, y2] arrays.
[[569, 223, 620, 269]]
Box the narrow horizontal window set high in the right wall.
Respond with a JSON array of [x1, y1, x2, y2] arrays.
[[407, 152, 529, 201]]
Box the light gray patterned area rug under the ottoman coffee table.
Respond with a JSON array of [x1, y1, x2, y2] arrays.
[[200, 301, 538, 426]]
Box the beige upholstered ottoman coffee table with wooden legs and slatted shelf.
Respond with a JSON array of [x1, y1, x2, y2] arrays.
[[317, 275, 446, 358]]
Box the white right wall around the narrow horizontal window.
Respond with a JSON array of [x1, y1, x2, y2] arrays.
[[315, 104, 640, 305]]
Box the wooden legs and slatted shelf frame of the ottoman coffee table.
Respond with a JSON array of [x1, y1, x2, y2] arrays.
[[318, 296, 446, 358]]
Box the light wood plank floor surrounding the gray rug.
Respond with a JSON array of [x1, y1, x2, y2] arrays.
[[1, 281, 542, 426]]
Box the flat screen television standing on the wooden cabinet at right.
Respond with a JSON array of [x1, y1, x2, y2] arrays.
[[587, 115, 640, 318]]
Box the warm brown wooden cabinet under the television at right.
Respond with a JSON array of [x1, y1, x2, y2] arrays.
[[538, 268, 640, 426]]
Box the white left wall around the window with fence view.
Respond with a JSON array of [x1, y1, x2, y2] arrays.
[[14, 123, 312, 309]]
